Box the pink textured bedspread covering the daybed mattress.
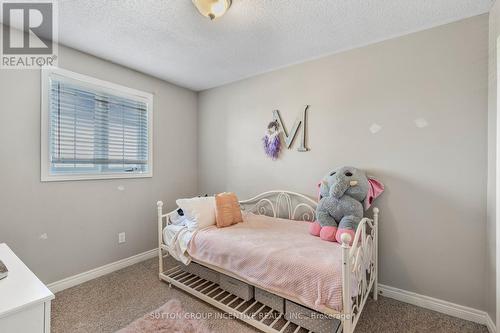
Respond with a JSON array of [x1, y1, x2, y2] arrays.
[[188, 214, 342, 311]]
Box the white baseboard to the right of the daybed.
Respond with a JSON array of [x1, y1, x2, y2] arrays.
[[378, 284, 496, 333]]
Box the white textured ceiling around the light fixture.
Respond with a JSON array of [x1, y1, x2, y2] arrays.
[[51, 0, 494, 90]]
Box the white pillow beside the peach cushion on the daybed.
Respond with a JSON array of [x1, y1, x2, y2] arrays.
[[175, 197, 215, 228]]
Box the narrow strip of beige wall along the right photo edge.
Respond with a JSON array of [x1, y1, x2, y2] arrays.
[[485, 2, 500, 322]]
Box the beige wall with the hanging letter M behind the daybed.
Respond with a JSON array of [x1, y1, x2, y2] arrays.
[[198, 15, 488, 310]]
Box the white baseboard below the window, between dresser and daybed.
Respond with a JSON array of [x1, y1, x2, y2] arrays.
[[47, 249, 158, 293]]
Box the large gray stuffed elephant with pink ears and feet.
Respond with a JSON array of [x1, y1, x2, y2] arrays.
[[309, 167, 384, 243]]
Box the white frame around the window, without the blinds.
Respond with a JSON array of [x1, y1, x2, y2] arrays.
[[40, 67, 154, 182]]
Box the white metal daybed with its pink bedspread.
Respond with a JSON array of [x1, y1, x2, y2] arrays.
[[157, 191, 379, 333]]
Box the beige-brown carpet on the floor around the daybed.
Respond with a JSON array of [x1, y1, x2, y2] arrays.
[[52, 259, 488, 333]]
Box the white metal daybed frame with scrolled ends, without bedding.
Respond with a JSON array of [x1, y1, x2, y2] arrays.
[[157, 191, 379, 333]]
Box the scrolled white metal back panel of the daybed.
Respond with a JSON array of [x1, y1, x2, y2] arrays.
[[240, 191, 318, 221]]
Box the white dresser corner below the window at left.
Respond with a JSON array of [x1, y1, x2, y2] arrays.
[[0, 244, 54, 333]]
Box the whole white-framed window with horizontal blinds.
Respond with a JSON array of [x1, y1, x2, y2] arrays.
[[41, 69, 153, 181]]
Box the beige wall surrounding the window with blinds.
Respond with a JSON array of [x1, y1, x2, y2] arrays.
[[0, 43, 197, 283]]
